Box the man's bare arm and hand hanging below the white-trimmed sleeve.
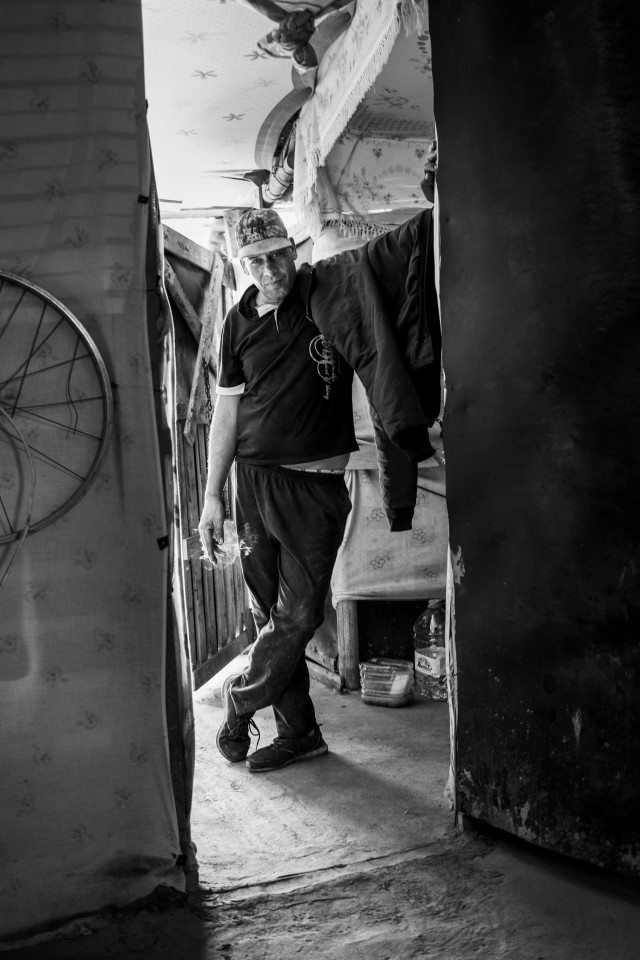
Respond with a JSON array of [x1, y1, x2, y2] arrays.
[[198, 394, 241, 565]]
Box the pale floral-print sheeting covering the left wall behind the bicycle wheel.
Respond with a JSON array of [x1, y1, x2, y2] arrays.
[[0, 0, 184, 940]]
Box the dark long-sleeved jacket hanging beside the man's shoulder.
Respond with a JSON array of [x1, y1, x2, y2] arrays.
[[299, 210, 441, 531]]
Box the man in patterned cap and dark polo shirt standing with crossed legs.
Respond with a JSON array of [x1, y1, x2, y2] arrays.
[[199, 209, 357, 773]]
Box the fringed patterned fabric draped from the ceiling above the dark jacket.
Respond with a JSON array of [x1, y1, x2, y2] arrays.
[[293, 0, 435, 237]]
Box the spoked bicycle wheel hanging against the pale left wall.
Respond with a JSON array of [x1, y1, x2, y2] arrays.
[[0, 269, 113, 544]]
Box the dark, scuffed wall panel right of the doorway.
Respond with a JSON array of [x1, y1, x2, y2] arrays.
[[430, 0, 640, 872]]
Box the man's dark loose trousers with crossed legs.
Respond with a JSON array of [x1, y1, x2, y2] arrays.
[[231, 464, 351, 737]]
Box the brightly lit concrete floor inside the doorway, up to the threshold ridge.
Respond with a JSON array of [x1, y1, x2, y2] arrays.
[[192, 668, 451, 891]]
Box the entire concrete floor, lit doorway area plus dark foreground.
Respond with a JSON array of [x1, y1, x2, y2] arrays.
[[5, 682, 640, 960]]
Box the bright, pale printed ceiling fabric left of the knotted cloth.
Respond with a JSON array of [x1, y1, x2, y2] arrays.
[[142, 0, 353, 213]]
